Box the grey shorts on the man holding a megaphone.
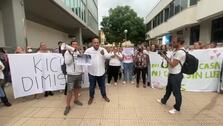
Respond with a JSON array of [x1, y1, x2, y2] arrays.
[[67, 75, 82, 91]]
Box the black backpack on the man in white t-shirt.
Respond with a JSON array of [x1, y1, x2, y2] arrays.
[[180, 49, 199, 75]]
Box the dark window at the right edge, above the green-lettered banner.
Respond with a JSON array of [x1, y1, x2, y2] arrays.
[[211, 17, 223, 42]]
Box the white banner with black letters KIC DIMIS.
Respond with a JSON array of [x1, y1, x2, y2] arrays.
[[8, 53, 66, 98]]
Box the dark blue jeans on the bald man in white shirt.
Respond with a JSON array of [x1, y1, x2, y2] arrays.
[[88, 74, 107, 98]]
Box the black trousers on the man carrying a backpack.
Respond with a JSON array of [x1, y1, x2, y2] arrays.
[[161, 73, 183, 111]]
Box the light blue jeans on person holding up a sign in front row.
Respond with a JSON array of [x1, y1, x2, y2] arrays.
[[123, 63, 133, 81]]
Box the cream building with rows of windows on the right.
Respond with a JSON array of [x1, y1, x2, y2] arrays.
[[145, 0, 223, 45]]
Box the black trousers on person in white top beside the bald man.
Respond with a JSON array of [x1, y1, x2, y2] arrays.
[[108, 66, 121, 83]]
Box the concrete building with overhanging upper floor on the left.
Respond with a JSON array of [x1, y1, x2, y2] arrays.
[[0, 0, 98, 51]]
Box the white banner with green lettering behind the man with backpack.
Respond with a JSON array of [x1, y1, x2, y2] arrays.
[[149, 48, 223, 91]]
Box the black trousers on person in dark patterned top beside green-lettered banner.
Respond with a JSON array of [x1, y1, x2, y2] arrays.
[[135, 67, 147, 85]]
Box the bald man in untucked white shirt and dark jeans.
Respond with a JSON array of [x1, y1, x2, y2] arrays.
[[85, 37, 111, 105]]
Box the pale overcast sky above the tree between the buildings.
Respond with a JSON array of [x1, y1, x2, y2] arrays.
[[98, 0, 159, 27]]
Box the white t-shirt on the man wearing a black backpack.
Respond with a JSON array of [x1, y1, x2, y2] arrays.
[[169, 48, 186, 74]]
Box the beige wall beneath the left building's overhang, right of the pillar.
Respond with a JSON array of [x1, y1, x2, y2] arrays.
[[26, 20, 70, 48]]
